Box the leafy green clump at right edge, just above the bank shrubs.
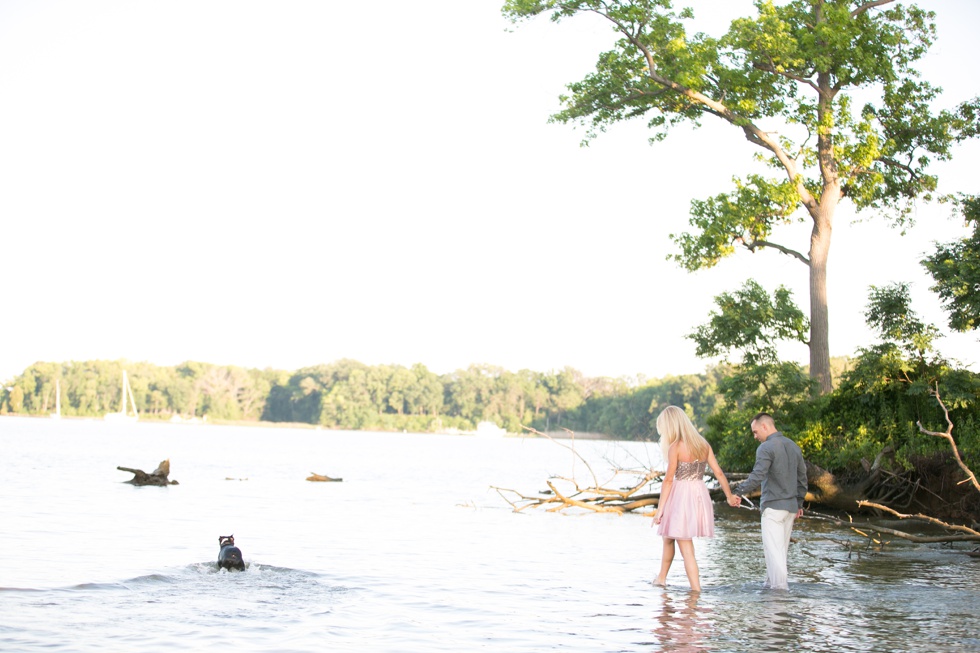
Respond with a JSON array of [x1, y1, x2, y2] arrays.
[[922, 197, 980, 331]]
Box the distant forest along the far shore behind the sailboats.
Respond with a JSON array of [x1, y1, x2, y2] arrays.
[[0, 360, 722, 439]]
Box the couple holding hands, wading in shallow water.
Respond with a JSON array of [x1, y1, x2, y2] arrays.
[[653, 406, 807, 592]]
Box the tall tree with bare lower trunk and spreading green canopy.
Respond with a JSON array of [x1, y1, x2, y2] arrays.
[[503, 0, 977, 392]]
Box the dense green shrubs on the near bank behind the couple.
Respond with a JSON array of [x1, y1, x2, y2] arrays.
[[706, 284, 980, 475]]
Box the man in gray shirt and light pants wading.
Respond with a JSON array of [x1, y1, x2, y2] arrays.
[[728, 413, 807, 589]]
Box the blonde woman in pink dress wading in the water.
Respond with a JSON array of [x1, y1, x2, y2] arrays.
[[653, 406, 735, 592]]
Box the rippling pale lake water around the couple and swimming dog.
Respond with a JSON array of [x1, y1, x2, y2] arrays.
[[0, 418, 980, 653]]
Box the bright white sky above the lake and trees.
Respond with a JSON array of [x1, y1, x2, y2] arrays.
[[0, 0, 980, 380]]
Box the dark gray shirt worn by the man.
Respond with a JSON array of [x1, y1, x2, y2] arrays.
[[733, 431, 807, 512]]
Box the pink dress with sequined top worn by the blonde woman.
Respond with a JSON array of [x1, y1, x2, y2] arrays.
[[657, 460, 715, 540]]
